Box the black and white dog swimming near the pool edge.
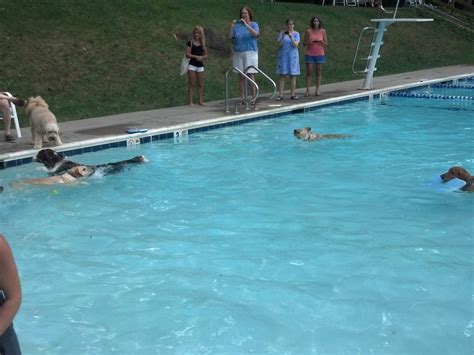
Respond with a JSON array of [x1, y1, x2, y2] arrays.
[[33, 148, 147, 175]]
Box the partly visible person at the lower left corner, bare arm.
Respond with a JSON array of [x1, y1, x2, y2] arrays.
[[0, 234, 22, 355]]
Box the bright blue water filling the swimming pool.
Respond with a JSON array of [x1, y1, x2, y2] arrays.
[[0, 93, 474, 354]]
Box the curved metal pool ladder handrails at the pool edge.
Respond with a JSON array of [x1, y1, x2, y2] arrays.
[[225, 65, 277, 114]]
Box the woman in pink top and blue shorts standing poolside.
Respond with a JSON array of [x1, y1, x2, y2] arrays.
[[303, 16, 328, 96]]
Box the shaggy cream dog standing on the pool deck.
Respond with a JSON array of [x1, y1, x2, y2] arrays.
[[25, 96, 63, 149]]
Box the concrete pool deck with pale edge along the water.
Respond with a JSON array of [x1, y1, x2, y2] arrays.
[[0, 65, 474, 161]]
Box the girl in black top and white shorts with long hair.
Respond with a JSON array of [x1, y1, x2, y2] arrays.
[[186, 26, 207, 106]]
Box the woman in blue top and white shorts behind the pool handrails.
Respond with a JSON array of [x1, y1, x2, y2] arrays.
[[229, 6, 260, 99]]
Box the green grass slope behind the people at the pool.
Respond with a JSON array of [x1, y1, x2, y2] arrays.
[[0, 0, 474, 125]]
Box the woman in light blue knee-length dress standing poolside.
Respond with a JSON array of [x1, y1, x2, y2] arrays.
[[276, 18, 300, 100]]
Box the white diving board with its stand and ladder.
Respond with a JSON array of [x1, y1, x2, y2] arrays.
[[352, 18, 433, 90]]
